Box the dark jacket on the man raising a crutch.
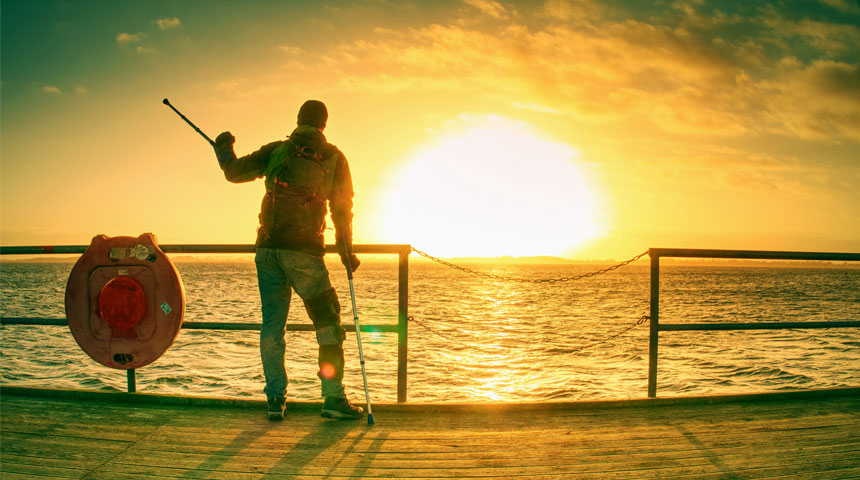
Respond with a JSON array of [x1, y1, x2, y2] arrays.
[[222, 125, 353, 256]]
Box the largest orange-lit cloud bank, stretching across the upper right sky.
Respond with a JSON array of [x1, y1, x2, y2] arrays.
[[298, 0, 860, 141]]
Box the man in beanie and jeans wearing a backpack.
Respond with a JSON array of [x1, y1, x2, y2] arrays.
[[215, 100, 364, 420]]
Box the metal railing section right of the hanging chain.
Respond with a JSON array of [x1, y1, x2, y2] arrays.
[[648, 248, 860, 398]]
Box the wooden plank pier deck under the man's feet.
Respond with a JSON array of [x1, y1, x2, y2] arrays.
[[0, 387, 860, 480]]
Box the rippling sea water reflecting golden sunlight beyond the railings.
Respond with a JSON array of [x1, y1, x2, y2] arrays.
[[0, 256, 860, 402]]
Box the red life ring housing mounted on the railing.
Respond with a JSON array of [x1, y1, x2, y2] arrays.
[[66, 233, 185, 370]]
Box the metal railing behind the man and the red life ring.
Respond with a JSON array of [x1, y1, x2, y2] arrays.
[[0, 244, 412, 403]]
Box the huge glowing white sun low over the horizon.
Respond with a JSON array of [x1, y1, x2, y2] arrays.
[[382, 117, 603, 257]]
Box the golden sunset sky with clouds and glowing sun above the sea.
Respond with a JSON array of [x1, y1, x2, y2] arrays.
[[0, 0, 860, 260]]
